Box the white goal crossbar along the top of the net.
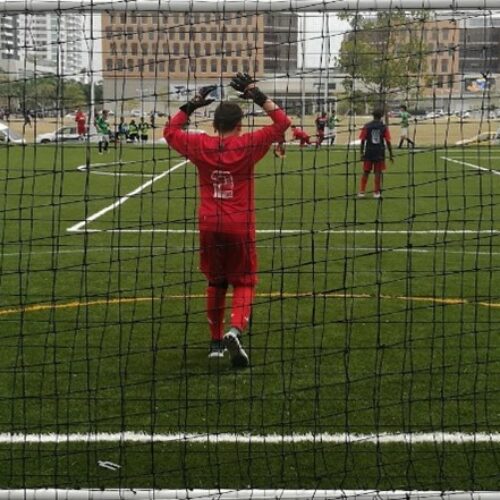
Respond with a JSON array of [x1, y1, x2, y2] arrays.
[[0, 0, 499, 13]]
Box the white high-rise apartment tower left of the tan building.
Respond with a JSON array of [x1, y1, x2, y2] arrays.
[[18, 14, 86, 78]]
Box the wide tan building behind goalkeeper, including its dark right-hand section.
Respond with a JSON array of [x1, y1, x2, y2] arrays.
[[102, 12, 306, 111]]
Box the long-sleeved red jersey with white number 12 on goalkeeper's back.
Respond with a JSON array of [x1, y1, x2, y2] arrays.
[[163, 109, 290, 233]]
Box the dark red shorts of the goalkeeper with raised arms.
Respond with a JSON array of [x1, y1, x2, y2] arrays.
[[200, 230, 257, 286]]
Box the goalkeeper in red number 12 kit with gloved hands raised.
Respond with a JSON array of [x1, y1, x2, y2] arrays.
[[163, 73, 290, 367]]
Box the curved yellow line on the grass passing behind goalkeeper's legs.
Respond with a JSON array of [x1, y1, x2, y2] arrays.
[[0, 292, 500, 316]]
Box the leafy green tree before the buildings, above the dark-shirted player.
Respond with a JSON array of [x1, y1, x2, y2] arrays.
[[339, 10, 426, 111]]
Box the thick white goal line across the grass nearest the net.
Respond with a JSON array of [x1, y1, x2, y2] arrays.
[[0, 432, 500, 445]]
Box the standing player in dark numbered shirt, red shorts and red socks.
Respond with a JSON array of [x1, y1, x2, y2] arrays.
[[358, 109, 394, 198]]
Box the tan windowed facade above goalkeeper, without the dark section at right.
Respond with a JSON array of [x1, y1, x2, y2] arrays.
[[102, 12, 264, 85]]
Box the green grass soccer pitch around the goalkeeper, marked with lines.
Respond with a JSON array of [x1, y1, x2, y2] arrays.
[[0, 145, 500, 490]]
